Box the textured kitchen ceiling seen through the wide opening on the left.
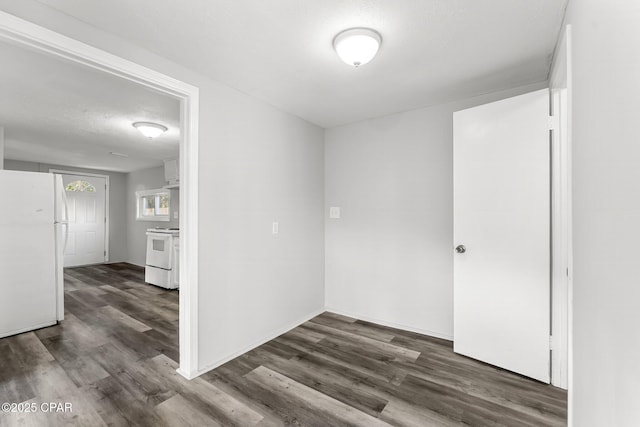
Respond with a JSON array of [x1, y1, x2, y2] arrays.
[[0, 39, 180, 172]]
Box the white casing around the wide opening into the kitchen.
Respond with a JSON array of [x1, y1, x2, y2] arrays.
[[0, 11, 199, 379]]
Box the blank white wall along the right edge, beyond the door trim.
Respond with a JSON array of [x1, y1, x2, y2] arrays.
[[566, 0, 640, 427]]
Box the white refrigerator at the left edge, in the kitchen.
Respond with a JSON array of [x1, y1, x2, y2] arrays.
[[0, 170, 67, 338]]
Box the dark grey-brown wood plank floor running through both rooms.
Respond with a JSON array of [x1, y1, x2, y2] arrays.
[[0, 264, 566, 426]]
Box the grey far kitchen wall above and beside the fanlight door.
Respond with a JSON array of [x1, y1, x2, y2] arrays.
[[4, 159, 128, 263]]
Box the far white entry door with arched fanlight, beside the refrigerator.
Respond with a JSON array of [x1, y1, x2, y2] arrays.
[[62, 175, 106, 267]]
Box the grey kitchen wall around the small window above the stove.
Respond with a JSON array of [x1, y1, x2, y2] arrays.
[[125, 166, 180, 266]]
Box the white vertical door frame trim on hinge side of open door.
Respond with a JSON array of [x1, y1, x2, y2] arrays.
[[549, 26, 572, 389]]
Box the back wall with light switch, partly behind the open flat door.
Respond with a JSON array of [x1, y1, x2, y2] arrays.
[[325, 83, 546, 339]]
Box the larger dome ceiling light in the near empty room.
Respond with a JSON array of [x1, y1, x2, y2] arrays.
[[333, 28, 382, 68]]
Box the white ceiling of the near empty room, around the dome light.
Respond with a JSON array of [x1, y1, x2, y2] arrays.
[[33, 0, 567, 127]]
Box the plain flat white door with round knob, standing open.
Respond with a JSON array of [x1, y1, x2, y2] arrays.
[[453, 89, 550, 383]]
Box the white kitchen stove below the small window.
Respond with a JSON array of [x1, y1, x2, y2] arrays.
[[144, 228, 180, 289]]
